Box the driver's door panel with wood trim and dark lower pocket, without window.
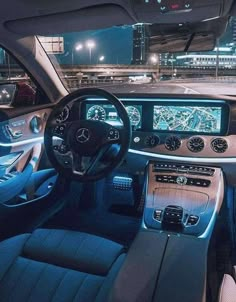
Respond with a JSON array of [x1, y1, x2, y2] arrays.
[[0, 105, 65, 240]]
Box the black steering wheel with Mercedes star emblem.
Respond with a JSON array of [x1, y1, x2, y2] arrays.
[[44, 88, 132, 181]]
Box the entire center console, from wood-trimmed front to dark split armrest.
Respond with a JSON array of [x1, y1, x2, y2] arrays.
[[109, 161, 224, 302]]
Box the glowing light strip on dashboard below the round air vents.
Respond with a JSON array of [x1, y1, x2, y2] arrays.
[[129, 149, 236, 164]]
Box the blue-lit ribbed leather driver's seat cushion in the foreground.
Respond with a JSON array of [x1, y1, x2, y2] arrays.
[[0, 229, 125, 302]]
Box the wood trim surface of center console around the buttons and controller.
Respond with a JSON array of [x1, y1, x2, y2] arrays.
[[144, 162, 224, 236]]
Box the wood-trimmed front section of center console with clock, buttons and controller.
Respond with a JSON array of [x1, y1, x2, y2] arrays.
[[143, 162, 224, 236]]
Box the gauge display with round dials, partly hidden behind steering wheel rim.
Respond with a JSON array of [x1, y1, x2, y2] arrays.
[[86, 104, 142, 129]]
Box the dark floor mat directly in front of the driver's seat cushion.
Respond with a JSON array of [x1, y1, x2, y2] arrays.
[[43, 208, 141, 247]]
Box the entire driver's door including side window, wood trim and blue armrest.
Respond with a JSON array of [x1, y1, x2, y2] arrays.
[[0, 47, 65, 240]]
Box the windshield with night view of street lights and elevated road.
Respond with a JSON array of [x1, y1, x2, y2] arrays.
[[38, 19, 236, 95]]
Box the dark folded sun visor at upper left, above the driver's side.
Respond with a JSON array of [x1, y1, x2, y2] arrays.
[[4, 5, 136, 36]]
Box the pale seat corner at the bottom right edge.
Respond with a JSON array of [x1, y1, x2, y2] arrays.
[[218, 268, 236, 302]]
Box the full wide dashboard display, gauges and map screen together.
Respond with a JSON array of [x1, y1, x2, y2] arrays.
[[86, 100, 227, 135]]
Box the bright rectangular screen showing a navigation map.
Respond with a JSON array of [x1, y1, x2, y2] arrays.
[[153, 105, 222, 134]]
